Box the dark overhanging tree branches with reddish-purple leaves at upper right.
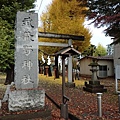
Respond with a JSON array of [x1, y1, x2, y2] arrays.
[[87, 0, 120, 44]]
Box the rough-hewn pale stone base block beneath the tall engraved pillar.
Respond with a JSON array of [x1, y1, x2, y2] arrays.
[[8, 88, 45, 111]]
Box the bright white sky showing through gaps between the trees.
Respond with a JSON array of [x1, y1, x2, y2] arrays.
[[36, 0, 112, 47]]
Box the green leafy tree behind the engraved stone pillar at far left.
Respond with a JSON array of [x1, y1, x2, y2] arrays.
[[0, 0, 35, 82]]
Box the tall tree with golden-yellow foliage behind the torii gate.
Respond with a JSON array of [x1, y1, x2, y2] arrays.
[[39, 0, 91, 54]]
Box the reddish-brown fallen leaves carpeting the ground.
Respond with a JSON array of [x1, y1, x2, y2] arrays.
[[0, 77, 120, 120]]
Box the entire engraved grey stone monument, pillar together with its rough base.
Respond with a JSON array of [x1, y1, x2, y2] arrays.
[[8, 12, 45, 111]]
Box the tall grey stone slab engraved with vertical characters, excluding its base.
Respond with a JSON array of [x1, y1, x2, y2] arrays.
[[15, 12, 38, 89]]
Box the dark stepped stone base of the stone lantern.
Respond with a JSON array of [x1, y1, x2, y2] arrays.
[[83, 80, 107, 93]]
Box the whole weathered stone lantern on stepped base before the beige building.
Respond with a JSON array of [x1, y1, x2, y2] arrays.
[[83, 59, 107, 93]]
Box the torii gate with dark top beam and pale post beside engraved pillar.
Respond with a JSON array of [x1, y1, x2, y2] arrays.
[[38, 32, 84, 83]]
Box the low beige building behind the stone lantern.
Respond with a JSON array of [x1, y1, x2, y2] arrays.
[[80, 55, 114, 78]]
